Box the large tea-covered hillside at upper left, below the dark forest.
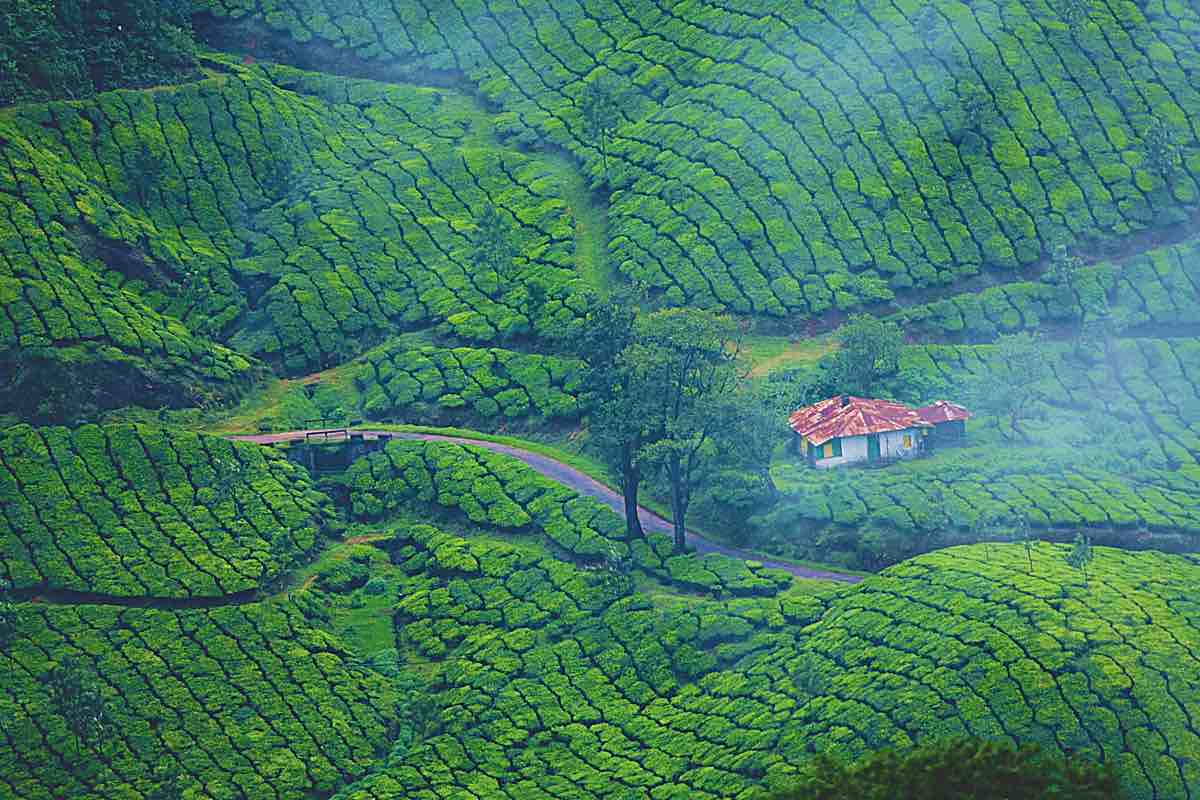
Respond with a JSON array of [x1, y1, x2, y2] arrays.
[[0, 54, 590, 386]]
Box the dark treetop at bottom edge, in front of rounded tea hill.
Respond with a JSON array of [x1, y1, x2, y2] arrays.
[[776, 739, 1121, 800]]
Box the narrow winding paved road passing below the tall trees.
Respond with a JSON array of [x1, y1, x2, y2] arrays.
[[228, 429, 863, 583]]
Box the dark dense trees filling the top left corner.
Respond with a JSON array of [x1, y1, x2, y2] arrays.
[[0, 0, 196, 106]]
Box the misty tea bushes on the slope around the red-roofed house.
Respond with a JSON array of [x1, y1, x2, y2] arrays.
[[750, 338, 1200, 566]]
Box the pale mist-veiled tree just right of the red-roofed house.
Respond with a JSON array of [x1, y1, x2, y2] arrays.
[[968, 331, 1051, 441]]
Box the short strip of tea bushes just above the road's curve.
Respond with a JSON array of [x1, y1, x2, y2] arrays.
[[355, 344, 582, 421]]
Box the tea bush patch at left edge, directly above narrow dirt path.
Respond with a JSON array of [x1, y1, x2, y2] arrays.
[[0, 425, 332, 597]]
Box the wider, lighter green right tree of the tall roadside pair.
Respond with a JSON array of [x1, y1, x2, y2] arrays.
[[619, 308, 743, 552]]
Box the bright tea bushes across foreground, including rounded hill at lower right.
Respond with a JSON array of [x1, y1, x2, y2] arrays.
[[337, 528, 1200, 800]]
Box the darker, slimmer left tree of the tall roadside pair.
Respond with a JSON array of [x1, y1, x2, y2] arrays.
[[570, 293, 648, 539]]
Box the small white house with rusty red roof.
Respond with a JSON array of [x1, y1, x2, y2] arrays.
[[788, 396, 970, 469]]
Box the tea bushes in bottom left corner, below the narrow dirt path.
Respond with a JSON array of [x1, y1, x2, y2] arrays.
[[0, 603, 396, 800]]
